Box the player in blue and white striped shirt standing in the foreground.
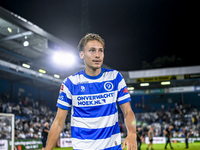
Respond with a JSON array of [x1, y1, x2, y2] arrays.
[[46, 33, 137, 150]]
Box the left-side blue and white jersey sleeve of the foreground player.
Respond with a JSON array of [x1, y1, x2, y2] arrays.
[[56, 79, 72, 110]]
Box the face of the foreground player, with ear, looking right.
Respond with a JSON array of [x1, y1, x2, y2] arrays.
[[79, 40, 104, 70]]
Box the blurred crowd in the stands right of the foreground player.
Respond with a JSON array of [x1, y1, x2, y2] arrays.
[[135, 103, 200, 137]]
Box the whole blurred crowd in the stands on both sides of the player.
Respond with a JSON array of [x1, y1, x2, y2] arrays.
[[0, 94, 200, 139]]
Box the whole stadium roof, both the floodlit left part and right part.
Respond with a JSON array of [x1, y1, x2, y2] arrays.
[[0, 7, 200, 90]]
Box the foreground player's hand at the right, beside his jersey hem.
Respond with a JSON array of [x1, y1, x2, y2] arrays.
[[122, 133, 137, 150]]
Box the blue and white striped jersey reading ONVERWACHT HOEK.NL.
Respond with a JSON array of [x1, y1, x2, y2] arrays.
[[57, 68, 131, 150]]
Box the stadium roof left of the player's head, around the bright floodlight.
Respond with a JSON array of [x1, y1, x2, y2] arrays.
[[0, 7, 84, 89]]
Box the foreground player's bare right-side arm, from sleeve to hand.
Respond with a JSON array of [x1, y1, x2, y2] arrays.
[[120, 102, 137, 150]]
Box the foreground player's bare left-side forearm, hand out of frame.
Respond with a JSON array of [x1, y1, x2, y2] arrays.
[[45, 108, 68, 150]]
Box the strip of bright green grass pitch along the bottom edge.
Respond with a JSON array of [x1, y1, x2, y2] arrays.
[[54, 143, 200, 150]]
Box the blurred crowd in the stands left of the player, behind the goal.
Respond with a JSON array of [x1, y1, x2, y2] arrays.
[[0, 97, 70, 139]]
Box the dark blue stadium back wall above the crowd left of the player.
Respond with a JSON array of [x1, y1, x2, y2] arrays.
[[0, 79, 59, 110]]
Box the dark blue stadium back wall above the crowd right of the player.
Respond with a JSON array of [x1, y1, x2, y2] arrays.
[[131, 92, 200, 113]]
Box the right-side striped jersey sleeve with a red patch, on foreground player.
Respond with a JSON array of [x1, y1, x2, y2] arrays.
[[117, 73, 131, 105]]
